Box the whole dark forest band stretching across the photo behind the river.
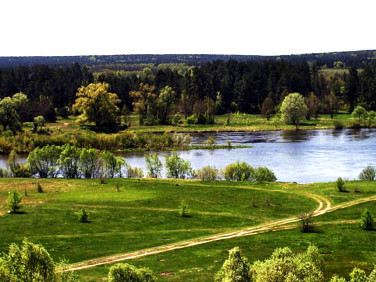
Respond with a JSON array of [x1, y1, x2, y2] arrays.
[[0, 60, 376, 121]]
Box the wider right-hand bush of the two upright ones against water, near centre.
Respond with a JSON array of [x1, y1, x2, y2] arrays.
[[165, 152, 192, 179]]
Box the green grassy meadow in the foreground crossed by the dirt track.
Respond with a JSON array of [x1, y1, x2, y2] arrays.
[[0, 179, 376, 281]]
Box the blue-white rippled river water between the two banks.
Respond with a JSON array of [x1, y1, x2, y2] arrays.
[[0, 129, 376, 183]]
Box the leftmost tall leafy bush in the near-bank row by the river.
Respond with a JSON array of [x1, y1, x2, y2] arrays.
[[26, 145, 61, 178]]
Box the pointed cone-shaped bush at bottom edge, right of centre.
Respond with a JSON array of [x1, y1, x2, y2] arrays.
[[214, 247, 252, 282]]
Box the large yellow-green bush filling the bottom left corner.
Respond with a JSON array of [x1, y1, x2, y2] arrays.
[[0, 239, 56, 282]]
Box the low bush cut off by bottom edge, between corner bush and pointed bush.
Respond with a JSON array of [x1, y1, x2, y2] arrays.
[[108, 263, 156, 282]]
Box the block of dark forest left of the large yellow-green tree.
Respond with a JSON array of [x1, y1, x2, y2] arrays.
[[0, 64, 94, 121]]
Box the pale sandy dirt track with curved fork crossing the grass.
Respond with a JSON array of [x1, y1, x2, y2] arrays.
[[69, 192, 376, 271]]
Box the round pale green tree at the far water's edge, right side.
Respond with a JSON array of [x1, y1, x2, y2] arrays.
[[281, 93, 308, 129]]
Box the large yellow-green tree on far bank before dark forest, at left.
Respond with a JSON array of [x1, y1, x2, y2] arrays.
[[73, 83, 120, 128]]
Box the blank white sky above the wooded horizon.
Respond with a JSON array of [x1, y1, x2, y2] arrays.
[[0, 0, 376, 56]]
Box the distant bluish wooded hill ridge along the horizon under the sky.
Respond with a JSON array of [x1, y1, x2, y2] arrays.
[[0, 50, 376, 69]]
